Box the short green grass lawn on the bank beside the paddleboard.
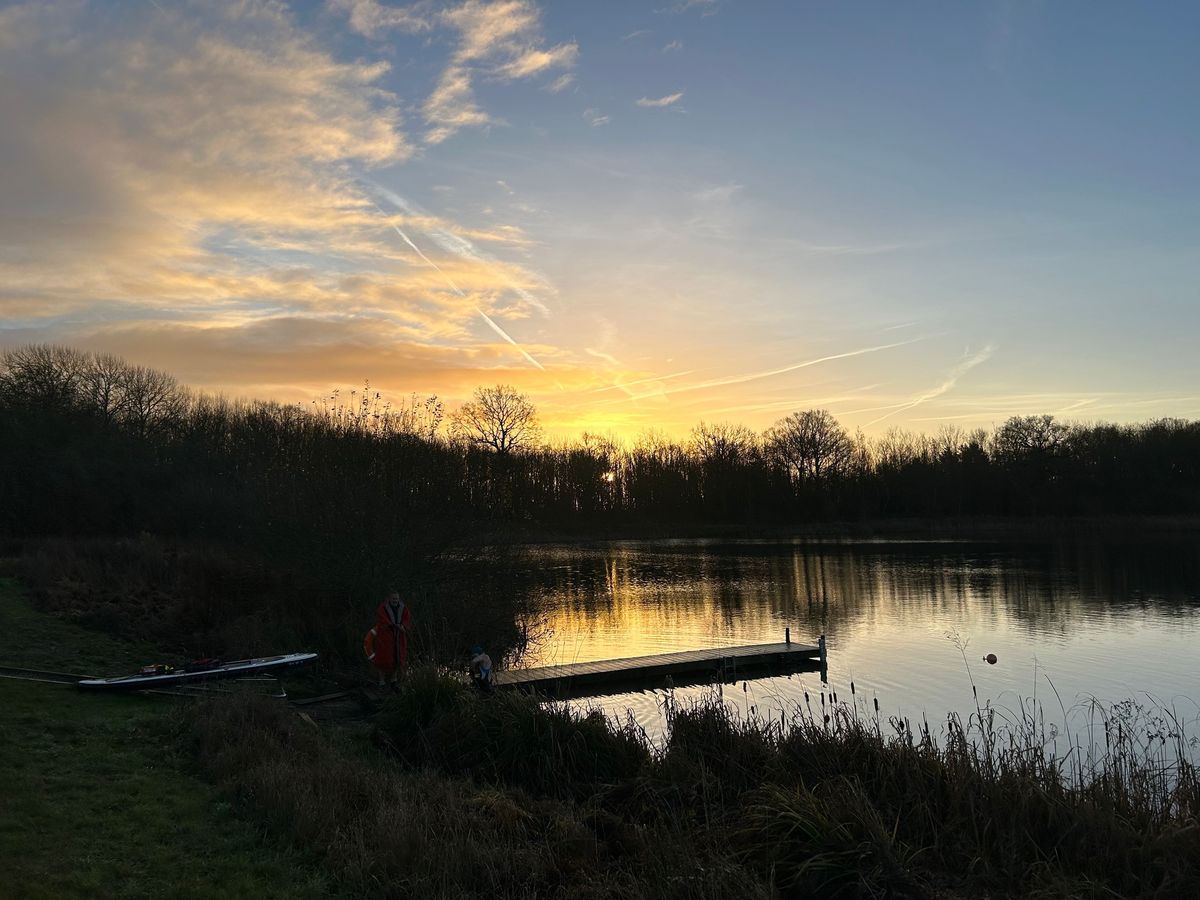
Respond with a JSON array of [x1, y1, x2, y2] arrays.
[[0, 580, 332, 899]]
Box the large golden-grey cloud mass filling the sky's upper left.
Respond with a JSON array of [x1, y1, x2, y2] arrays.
[[0, 0, 554, 374]]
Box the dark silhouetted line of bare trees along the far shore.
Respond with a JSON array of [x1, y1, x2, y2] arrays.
[[0, 346, 1200, 556]]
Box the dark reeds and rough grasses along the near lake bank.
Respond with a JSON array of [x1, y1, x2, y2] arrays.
[[193, 670, 1200, 898]]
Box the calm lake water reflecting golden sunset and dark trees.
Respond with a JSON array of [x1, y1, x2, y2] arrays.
[[511, 538, 1200, 736]]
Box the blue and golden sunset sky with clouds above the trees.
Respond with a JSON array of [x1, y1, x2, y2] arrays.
[[0, 0, 1200, 439]]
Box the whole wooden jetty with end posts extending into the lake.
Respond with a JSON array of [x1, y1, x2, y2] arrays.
[[492, 632, 826, 696]]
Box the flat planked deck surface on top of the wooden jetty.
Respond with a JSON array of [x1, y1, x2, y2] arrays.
[[493, 642, 821, 688]]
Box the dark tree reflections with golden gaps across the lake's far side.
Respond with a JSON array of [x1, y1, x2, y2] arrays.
[[521, 541, 1200, 646]]
